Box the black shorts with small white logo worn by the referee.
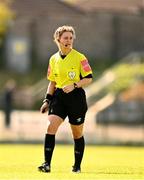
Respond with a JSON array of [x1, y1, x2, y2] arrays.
[[48, 88, 87, 125]]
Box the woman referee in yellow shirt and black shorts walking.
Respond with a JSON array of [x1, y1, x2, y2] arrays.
[[38, 26, 92, 173]]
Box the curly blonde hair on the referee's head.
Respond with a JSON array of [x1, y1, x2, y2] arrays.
[[54, 25, 76, 43]]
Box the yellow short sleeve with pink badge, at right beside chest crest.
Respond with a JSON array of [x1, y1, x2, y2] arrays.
[[80, 55, 92, 77]]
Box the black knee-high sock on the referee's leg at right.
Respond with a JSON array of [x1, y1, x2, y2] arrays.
[[74, 136, 85, 167]]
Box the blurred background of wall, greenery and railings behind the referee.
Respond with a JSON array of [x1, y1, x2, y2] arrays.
[[0, 0, 144, 145]]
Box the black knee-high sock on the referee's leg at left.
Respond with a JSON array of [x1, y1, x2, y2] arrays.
[[44, 134, 55, 165]]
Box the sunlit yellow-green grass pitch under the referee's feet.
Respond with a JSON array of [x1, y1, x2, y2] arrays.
[[0, 145, 144, 180]]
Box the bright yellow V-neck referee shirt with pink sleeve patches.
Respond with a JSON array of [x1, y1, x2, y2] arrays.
[[47, 49, 92, 88]]
